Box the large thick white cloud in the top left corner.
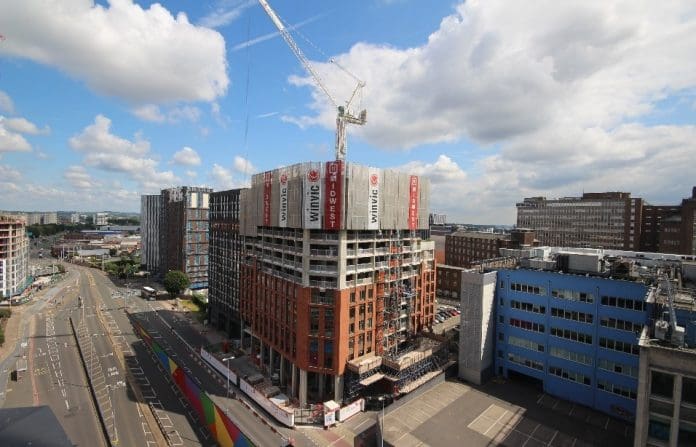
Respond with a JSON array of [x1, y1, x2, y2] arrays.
[[0, 0, 229, 104]]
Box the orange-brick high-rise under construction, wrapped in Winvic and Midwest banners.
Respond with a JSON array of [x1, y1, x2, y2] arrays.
[[240, 161, 435, 405]]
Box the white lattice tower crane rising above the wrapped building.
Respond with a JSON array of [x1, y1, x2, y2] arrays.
[[259, 0, 367, 160]]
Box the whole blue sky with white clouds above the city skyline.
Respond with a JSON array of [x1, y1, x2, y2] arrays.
[[0, 0, 696, 224]]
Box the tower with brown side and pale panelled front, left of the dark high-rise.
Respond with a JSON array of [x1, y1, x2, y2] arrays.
[[159, 186, 212, 290]]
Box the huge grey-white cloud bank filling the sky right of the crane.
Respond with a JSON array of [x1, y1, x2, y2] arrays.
[[283, 0, 696, 223]]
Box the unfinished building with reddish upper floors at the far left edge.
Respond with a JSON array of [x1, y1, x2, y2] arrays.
[[0, 215, 29, 298]]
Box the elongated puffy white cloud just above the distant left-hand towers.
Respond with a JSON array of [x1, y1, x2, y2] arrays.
[[69, 115, 178, 191]]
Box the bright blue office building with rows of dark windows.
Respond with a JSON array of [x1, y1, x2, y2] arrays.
[[495, 269, 654, 420]]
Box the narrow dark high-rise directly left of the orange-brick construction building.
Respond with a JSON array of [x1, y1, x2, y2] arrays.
[[208, 189, 243, 337]]
